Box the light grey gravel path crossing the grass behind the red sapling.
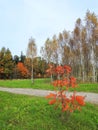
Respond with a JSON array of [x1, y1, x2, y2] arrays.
[[0, 87, 98, 104]]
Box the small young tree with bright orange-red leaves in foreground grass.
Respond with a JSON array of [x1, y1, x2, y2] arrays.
[[46, 65, 85, 112]]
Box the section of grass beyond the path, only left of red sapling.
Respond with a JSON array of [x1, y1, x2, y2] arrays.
[[0, 79, 53, 90]]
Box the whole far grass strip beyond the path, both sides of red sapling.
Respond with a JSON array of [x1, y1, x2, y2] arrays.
[[0, 79, 98, 93]]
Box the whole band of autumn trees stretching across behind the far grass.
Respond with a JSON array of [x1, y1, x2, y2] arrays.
[[0, 11, 98, 82]]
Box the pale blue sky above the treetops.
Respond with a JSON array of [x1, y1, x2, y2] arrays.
[[0, 0, 98, 55]]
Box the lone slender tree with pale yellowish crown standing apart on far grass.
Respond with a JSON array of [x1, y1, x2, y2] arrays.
[[27, 37, 37, 83]]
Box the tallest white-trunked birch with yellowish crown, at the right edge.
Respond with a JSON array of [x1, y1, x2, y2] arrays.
[[85, 11, 98, 82]]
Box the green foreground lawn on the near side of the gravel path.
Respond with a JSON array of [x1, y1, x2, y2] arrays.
[[0, 92, 98, 130]]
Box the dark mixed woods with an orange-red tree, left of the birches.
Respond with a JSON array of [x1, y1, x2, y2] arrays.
[[0, 47, 48, 79]]
